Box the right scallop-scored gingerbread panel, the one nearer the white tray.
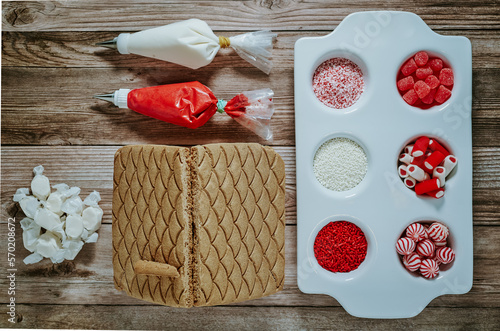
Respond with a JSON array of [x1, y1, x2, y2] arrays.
[[193, 144, 285, 305]]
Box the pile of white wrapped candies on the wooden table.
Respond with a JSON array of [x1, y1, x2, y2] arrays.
[[13, 165, 103, 264]]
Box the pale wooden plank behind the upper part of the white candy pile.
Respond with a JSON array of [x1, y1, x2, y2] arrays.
[[0, 146, 500, 225]]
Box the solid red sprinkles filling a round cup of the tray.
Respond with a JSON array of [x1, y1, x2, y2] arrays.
[[314, 221, 368, 272]]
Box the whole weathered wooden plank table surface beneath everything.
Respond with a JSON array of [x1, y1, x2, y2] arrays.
[[0, 0, 500, 330]]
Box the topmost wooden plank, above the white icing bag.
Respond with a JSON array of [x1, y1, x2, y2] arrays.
[[2, 0, 500, 31]]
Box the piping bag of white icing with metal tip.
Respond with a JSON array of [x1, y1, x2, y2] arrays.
[[97, 19, 276, 74]]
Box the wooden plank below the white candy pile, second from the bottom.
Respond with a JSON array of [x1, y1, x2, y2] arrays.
[[0, 224, 500, 308]]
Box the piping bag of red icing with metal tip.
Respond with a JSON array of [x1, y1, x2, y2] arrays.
[[94, 81, 274, 140]]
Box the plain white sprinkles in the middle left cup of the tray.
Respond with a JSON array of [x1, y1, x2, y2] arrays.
[[313, 138, 368, 192]]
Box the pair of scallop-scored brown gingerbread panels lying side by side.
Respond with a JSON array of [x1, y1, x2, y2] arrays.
[[113, 144, 285, 307]]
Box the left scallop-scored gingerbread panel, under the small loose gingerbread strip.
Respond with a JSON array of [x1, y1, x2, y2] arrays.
[[112, 146, 192, 307]]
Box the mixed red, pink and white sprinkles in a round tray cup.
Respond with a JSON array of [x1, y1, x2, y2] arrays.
[[313, 57, 365, 109]]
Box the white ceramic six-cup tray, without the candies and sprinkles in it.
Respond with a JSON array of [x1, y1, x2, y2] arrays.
[[295, 12, 473, 318]]
